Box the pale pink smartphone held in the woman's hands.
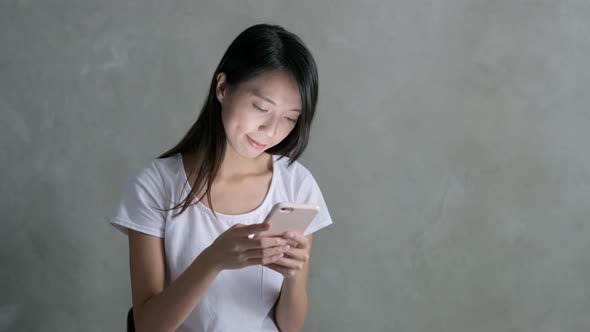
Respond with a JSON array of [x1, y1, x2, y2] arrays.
[[260, 202, 320, 245]]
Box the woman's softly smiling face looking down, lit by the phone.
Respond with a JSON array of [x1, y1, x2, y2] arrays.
[[216, 71, 301, 158]]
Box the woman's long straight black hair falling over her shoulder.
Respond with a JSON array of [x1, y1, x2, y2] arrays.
[[158, 24, 318, 218]]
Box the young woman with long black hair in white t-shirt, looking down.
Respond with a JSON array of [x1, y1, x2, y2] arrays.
[[110, 24, 332, 332]]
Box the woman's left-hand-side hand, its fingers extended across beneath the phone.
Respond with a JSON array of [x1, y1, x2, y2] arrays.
[[205, 223, 289, 271]]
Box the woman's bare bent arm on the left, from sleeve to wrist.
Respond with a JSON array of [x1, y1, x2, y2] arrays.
[[129, 229, 220, 332]]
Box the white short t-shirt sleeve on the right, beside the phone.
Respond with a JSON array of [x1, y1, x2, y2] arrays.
[[295, 167, 332, 235]]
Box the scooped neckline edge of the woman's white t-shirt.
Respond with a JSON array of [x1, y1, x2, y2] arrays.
[[177, 153, 279, 224]]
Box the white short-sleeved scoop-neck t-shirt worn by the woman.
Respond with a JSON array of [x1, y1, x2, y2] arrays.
[[109, 153, 332, 332]]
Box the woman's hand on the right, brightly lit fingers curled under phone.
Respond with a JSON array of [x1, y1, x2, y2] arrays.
[[264, 232, 311, 278]]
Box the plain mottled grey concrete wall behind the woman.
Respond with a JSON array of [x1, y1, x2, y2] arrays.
[[0, 0, 590, 332]]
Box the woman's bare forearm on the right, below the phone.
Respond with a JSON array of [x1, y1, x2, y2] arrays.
[[275, 234, 313, 332]]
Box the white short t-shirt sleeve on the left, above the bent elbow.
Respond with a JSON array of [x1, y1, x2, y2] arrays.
[[109, 163, 166, 238]]
